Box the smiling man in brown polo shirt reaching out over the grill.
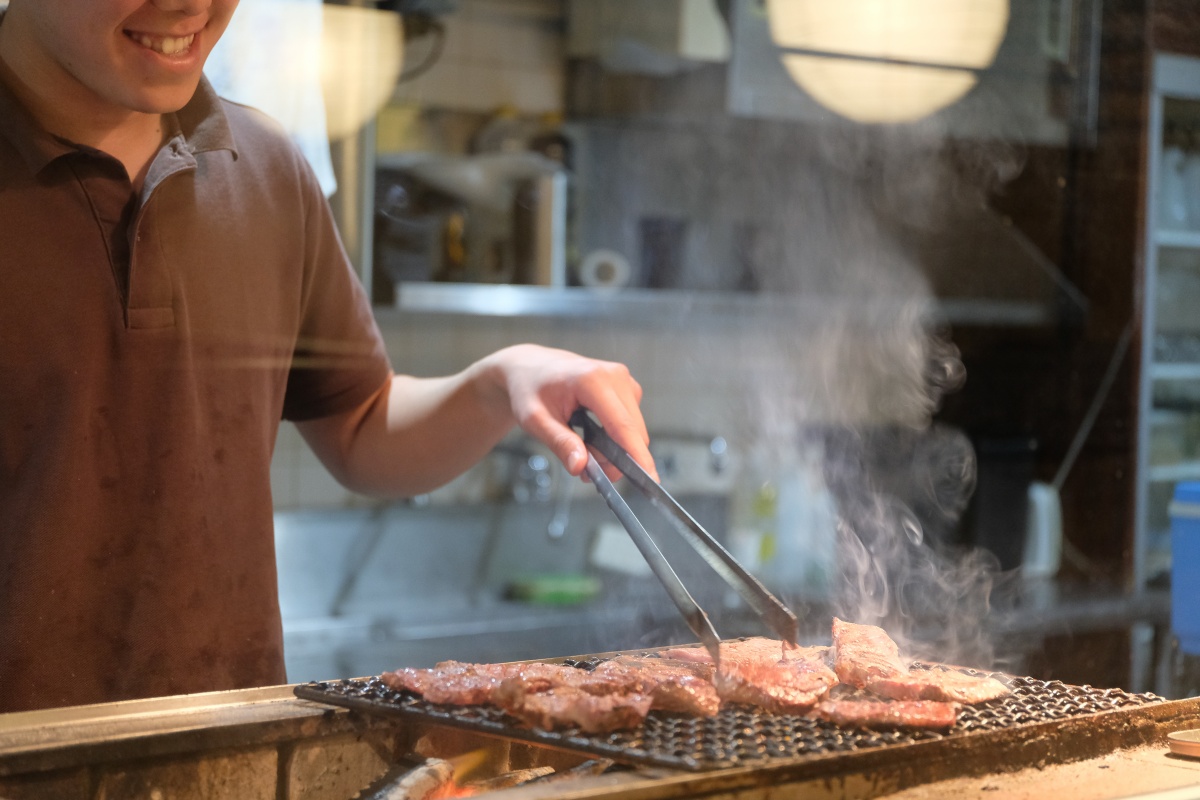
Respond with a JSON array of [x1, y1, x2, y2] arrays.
[[0, 0, 653, 710]]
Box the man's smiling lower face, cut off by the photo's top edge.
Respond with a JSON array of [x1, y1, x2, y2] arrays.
[[0, 0, 238, 114]]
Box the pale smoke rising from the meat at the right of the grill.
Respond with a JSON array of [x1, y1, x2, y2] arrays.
[[746, 118, 1022, 667]]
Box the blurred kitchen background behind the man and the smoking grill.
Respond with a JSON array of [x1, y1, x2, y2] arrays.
[[208, 0, 1200, 694]]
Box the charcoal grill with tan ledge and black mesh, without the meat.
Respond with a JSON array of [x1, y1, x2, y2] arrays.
[[0, 678, 1200, 800]]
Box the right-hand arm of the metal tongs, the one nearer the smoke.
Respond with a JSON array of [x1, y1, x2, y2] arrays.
[[571, 407, 800, 645]]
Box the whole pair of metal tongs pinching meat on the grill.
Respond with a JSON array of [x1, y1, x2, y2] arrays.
[[571, 408, 799, 668]]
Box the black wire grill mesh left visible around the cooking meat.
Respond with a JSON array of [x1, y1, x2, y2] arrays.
[[295, 660, 1163, 770]]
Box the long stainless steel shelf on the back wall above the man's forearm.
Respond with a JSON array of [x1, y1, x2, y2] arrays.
[[378, 283, 1054, 326]]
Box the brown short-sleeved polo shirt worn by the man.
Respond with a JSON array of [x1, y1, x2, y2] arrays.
[[0, 68, 389, 711]]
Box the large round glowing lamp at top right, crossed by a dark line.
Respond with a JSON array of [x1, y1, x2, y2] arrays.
[[767, 0, 1009, 122]]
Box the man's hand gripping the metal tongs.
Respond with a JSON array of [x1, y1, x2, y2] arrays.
[[479, 344, 658, 480]]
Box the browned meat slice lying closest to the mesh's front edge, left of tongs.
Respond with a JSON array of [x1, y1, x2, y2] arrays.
[[494, 686, 652, 733]]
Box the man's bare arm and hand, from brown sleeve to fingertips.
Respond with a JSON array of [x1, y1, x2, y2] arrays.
[[298, 344, 656, 497]]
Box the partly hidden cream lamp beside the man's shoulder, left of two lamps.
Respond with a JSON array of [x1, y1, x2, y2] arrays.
[[320, 2, 404, 142]]
